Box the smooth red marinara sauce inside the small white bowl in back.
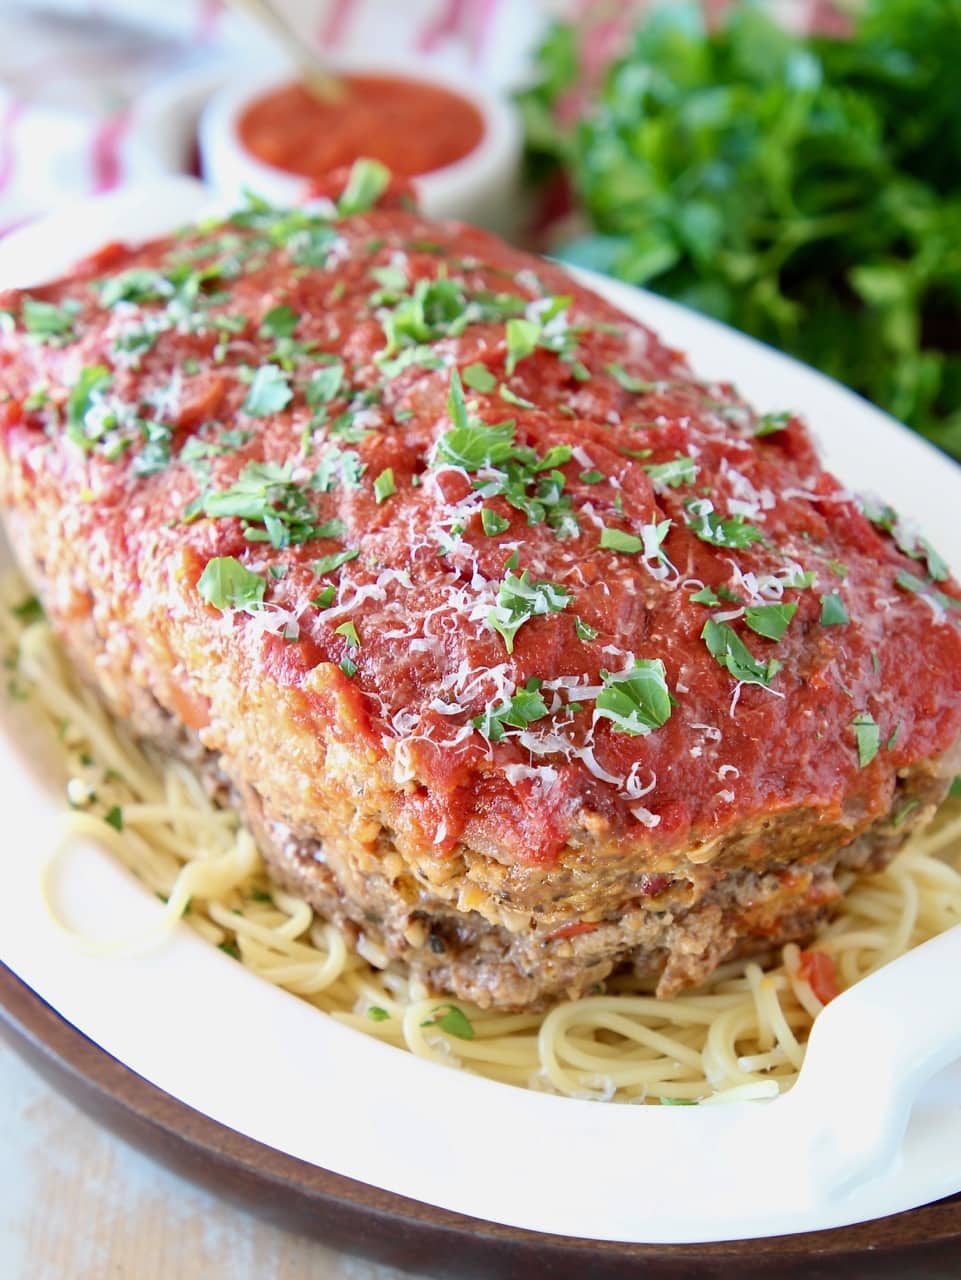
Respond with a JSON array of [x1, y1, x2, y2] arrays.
[[238, 76, 484, 178]]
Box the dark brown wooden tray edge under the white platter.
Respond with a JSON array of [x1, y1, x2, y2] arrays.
[[0, 965, 961, 1280]]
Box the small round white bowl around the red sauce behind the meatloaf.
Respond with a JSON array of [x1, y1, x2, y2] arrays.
[[200, 60, 522, 236]]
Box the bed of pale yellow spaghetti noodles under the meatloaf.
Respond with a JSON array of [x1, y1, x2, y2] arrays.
[[7, 575, 961, 1103]]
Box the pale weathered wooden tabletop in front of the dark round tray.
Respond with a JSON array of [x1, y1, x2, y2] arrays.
[[0, 1041, 414, 1280]]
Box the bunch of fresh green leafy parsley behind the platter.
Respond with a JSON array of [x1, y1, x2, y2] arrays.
[[521, 0, 961, 457]]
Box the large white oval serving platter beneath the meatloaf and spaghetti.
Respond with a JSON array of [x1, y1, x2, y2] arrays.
[[0, 179, 961, 1243]]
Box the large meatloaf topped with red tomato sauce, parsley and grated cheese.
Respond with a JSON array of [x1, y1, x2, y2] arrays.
[[0, 165, 961, 1009]]
